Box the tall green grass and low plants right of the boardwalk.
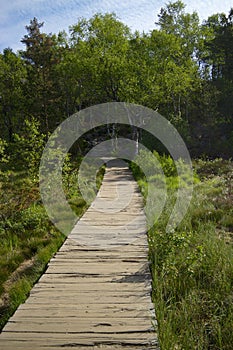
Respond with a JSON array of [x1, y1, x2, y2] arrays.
[[132, 154, 233, 350]]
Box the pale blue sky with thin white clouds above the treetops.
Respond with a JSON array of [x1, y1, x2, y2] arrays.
[[0, 0, 233, 52]]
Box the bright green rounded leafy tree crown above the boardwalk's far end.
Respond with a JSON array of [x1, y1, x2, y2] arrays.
[[67, 14, 130, 105]]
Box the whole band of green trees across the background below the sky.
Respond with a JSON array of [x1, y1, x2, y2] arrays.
[[0, 1, 233, 157]]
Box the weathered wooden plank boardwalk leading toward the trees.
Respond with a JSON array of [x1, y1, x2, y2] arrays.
[[0, 161, 158, 350]]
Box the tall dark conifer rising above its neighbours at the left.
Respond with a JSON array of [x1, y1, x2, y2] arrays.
[[20, 18, 62, 137]]
